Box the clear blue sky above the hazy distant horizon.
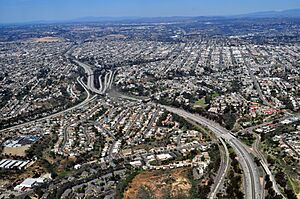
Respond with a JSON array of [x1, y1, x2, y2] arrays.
[[0, 0, 300, 23]]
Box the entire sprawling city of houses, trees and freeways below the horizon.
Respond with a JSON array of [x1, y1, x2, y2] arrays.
[[0, 12, 300, 199]]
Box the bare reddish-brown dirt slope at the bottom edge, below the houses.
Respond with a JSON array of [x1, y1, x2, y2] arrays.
[[123, 168, 192, 199]]
